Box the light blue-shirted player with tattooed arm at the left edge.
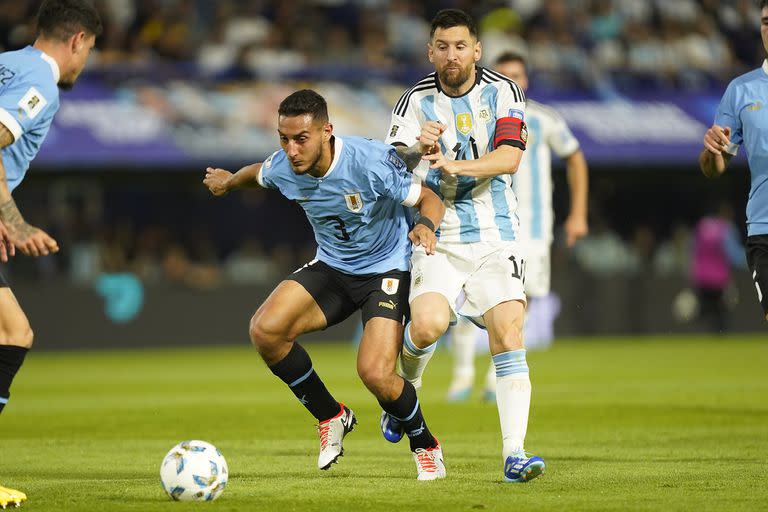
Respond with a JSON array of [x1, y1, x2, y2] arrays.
[[0, 0, 102, 507]]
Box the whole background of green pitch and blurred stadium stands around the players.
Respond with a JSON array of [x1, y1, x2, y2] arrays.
[[0, 0, 768, 512]]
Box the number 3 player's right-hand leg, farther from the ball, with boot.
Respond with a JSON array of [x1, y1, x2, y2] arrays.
[[357, 272, 445, 480]]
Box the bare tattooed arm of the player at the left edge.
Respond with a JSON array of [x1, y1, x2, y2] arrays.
[[0, 123, 59, 259]]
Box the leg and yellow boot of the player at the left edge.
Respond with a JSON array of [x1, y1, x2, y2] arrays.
[[0, 274, 32, 508]]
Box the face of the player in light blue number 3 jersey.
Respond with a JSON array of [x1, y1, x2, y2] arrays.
[[277, 114, 332, 174]]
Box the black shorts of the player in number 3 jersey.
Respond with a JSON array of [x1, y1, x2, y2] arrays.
[[287, 261, 411, 327]]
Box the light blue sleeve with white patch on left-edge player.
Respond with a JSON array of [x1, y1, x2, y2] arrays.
[[0, 74, 58, 141]]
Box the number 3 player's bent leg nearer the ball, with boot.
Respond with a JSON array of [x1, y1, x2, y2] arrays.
[[250, 263, 356, 469]]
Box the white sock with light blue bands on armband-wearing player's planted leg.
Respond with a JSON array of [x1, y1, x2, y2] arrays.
[[493, 349, 531, 459]]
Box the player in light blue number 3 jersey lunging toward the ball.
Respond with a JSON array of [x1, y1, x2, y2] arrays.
[[204, 90, 445, 480]]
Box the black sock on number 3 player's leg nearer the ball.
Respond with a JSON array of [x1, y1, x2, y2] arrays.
[[269, 342, 341, 421]]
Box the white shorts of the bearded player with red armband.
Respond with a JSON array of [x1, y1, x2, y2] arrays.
[[409, 242, 526, 325]]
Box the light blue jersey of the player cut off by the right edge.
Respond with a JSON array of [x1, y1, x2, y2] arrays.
[[715, 61, 768, 236]]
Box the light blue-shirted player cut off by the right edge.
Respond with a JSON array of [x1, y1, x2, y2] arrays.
[[699, 0, 768, 320]]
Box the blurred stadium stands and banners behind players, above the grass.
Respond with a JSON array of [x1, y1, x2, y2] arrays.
[[0, 0, 762, 348]]
